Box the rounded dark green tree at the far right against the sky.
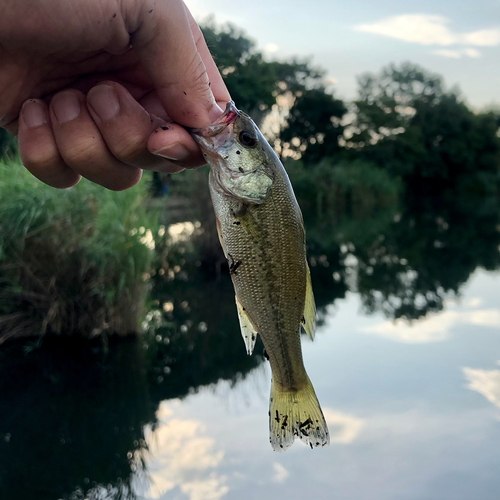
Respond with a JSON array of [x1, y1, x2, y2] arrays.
[[348, 63, 500, 194]]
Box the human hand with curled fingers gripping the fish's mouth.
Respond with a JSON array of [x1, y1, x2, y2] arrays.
[[0, 0, 230, 190]]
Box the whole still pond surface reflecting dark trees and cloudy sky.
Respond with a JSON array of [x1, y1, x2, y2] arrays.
[[0, 192, 500, 500]]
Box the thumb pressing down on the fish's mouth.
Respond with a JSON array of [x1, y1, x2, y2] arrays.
[[127, 0, 230, 127]]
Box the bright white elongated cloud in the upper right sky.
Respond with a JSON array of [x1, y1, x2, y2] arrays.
[[354, 14, 500, 48]]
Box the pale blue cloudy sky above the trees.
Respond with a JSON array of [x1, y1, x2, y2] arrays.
[[185, 0, 500, 110]]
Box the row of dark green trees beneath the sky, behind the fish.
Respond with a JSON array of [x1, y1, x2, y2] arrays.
[[202, 22, 500, 194]]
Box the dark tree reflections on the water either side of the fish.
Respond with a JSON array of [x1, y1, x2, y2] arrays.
[[0, 185, 500, 500]]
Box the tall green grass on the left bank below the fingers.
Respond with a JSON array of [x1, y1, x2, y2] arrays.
[[0, 161, 156, 336]]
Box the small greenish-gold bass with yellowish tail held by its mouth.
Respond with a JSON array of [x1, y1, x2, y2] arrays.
[[190, 101, 330, 451]]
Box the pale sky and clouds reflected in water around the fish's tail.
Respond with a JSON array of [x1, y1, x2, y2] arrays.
[[135, 271, 500, 500]]
